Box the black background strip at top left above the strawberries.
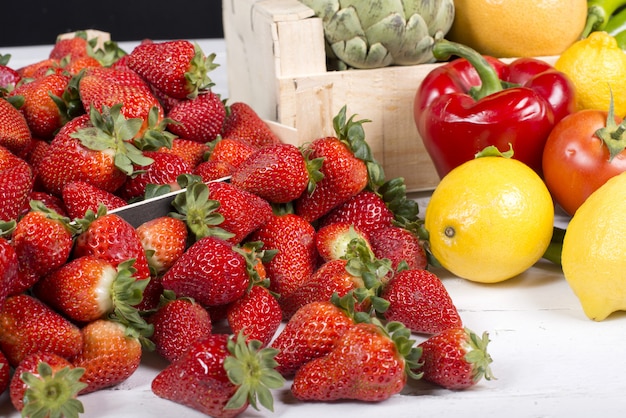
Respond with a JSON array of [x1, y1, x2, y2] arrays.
[[0, 0, 223, 46]]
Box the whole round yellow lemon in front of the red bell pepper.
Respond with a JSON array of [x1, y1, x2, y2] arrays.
[[424, 156, 554, 283]]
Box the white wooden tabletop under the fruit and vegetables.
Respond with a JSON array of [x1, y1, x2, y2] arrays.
[[0, 40, 626, 418]]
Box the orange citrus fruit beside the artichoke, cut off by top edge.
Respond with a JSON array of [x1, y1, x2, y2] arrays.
[[446, 0, 587, 57]]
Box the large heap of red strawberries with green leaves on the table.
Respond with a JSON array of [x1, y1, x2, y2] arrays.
[[0, 34, 492, 417]]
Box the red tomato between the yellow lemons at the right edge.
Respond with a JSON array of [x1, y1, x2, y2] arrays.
[[543, 109, 626, 215]]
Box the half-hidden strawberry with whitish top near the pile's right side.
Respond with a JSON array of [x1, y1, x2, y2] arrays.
[[315, 222, 371, 261]]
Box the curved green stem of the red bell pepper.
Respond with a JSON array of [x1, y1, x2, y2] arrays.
[[433, 39, 503, 100]]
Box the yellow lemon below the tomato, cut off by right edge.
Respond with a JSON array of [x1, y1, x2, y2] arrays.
[[561, 173, 626, 321]]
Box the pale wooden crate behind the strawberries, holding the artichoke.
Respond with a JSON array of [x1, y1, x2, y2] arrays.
[[222, 0, 556, 191]]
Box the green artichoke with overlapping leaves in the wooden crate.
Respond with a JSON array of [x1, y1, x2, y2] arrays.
[[300, 0, 454, 68]]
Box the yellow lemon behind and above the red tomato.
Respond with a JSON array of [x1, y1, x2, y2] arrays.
[[554, 32, 626, 117]]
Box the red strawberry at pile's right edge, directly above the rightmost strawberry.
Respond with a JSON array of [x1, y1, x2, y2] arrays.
[[381, 269, 462, 334]]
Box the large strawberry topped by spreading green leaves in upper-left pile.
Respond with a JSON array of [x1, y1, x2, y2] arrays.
[[37, 106, 145, 196]]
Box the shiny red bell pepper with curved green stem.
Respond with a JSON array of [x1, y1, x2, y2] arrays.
[[413, 40, 576, 177]]
